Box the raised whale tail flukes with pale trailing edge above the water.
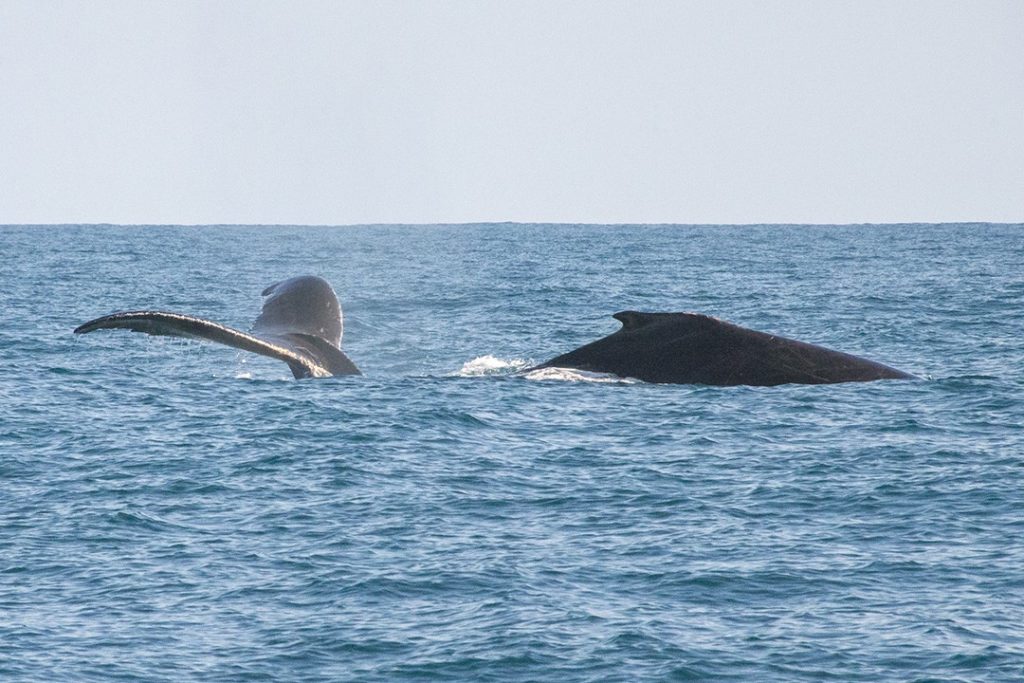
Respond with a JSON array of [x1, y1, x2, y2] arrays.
[[75, 275, 360, 379]]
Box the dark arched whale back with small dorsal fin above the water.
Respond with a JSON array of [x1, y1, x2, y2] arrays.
[[535, 310, 913, 386]]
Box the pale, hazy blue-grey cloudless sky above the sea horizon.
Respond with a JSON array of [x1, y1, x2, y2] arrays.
[[0, 0, 1024, 224]]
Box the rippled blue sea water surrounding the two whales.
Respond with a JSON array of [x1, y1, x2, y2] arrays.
[[0, 224, 1024, 683]]
